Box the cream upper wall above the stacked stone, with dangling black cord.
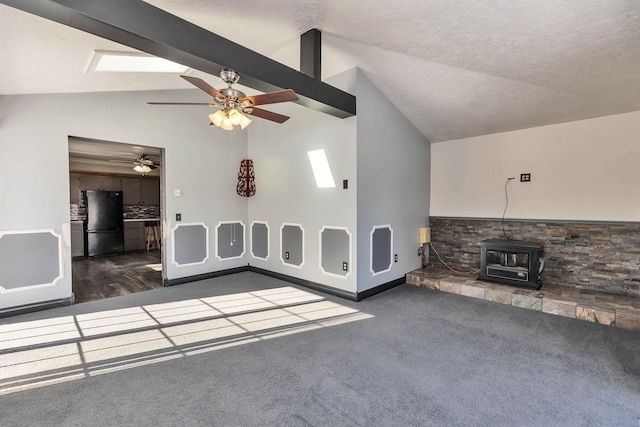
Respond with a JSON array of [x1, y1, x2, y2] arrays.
[[430, 112, 640, 221]]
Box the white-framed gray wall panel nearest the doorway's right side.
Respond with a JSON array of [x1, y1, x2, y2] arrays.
[[171, 222, 209, 267]]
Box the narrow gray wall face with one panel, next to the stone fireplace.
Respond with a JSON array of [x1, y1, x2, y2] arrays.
[[356, 71, 430, 292]]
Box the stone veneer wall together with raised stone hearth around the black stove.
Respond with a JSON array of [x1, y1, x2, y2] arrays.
[[406, 217, 640, 331]]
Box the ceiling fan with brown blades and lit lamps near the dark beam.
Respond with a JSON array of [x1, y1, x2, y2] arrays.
[[147, 68, 298, 130]]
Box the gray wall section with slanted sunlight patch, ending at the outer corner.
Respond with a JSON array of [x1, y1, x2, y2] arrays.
[[249, 103, 357, 292]]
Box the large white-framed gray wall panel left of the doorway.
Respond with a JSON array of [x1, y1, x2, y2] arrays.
[[0, 229, 64, 294]]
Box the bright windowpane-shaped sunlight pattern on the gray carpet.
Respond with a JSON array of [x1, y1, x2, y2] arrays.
[[0, 287, 373, 395]]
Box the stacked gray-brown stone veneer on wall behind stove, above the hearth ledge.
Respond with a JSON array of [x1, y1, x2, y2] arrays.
[[429, 217, 640, 299]]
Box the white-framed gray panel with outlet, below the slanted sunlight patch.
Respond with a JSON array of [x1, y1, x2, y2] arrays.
[[318, 225, 353, 279]]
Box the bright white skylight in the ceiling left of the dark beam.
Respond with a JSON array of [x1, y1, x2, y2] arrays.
[[87, 50, 189, 74]]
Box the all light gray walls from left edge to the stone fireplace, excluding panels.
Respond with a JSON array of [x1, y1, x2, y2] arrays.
[[0, 70, 430, 308]]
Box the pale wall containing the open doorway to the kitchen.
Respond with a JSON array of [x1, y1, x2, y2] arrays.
[[0, 90, 248, 308]]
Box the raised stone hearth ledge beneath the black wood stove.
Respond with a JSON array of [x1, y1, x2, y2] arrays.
[[406, 268, 640, 331]]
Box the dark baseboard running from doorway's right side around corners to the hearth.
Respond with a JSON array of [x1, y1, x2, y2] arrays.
[[162, 265, 406, 302]]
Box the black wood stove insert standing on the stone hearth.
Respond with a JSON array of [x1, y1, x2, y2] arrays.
[[478, 239, 544, 289]]
